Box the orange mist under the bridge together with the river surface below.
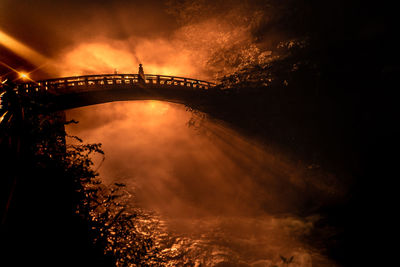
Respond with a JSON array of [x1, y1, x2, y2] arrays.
[[67, 101, 343, 266]]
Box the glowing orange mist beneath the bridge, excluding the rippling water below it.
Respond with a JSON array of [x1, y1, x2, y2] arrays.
[[67, 101, 345, 219]]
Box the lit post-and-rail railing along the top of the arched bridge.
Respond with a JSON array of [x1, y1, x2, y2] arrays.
[[19, 74, 216, 93]]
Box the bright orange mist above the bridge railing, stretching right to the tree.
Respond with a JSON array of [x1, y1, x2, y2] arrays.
[[54, 19, 249, 81]]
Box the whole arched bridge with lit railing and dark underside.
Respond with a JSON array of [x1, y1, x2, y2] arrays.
[[17, 74, 220, 109]]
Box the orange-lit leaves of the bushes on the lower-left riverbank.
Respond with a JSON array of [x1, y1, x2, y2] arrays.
[[65, 132, 166, 266]]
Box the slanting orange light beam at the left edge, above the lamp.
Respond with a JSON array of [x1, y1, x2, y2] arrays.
[[0, 30, 47, 65]]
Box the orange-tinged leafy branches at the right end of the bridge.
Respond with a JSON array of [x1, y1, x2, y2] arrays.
[[219, 38, 318, 90]]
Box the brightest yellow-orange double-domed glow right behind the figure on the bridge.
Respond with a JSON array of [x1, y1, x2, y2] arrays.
[[54, 40, 198, 78]]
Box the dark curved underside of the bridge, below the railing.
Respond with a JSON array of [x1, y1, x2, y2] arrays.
[[25, 84, 218, 111]]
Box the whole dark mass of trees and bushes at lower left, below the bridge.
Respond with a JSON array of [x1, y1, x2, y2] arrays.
[[0, 83, 162, 266]]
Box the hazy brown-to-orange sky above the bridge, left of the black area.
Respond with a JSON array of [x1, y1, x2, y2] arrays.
[[0, 0, 272, 79]]
